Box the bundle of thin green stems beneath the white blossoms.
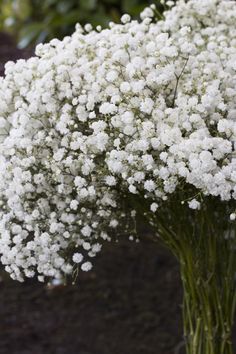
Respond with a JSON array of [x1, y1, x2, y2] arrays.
[[149, 196, 236, 354]]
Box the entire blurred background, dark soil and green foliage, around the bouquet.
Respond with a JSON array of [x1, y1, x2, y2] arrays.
[[0, 0, 184, 354]]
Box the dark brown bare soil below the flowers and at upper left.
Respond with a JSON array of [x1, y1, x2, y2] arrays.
[[0, 34, 233, 354]]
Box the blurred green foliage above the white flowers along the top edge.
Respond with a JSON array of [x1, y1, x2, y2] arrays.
[[0, 0, 161, 48]]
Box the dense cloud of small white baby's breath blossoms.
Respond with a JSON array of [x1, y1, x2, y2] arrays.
[[0, 0, 236, 281]]
